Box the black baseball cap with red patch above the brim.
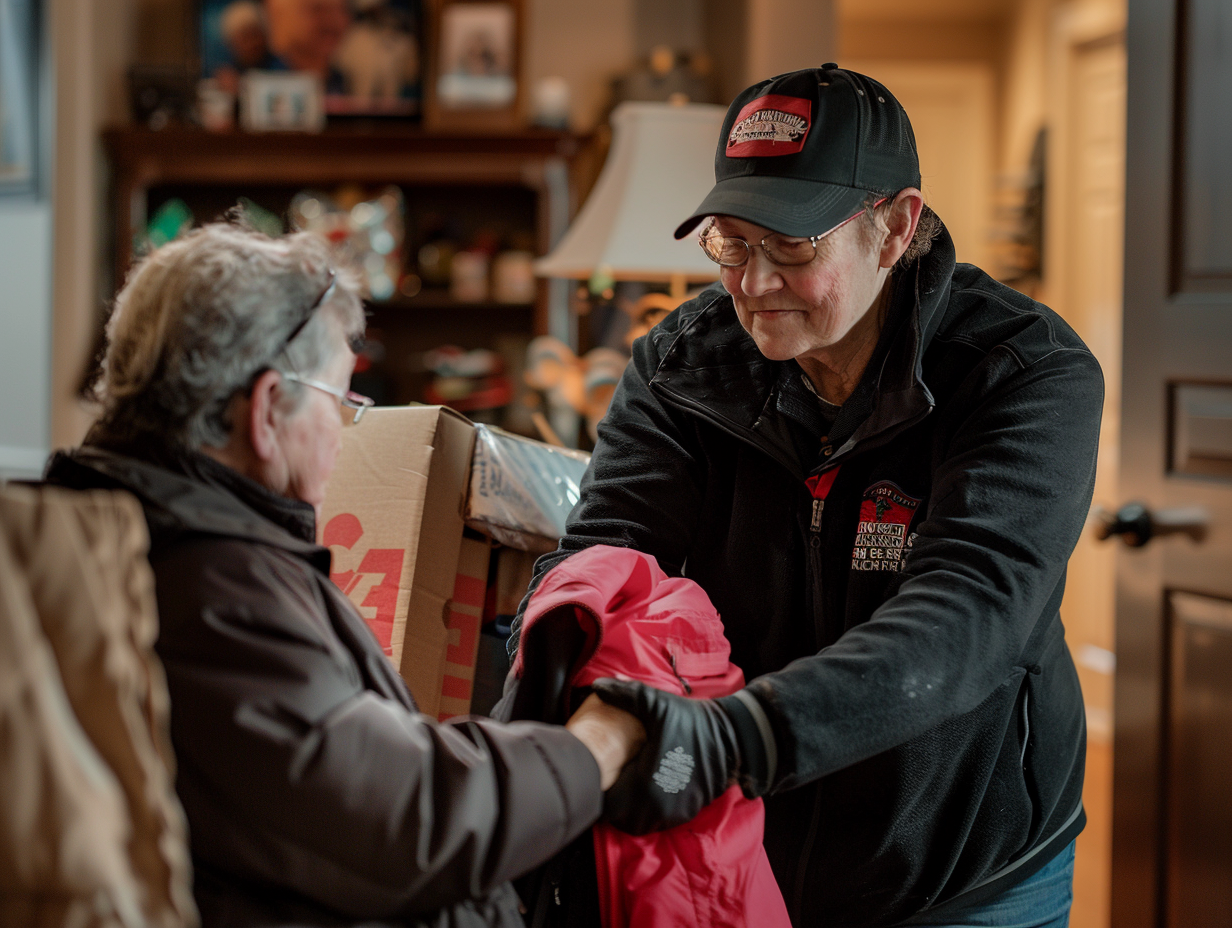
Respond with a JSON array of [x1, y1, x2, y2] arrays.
[[676, 64, 920, 239]]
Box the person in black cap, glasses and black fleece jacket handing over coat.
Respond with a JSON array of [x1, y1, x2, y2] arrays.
[[513, 65, 1103, 928]]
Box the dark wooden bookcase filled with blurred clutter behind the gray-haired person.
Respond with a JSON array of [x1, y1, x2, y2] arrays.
[[103, 123, 594, 444]]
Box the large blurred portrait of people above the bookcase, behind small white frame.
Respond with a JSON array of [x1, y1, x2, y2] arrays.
[[200, 0, 424, 116]]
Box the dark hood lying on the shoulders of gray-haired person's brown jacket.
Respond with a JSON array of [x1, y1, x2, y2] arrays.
[[44, 445, 329, 573]]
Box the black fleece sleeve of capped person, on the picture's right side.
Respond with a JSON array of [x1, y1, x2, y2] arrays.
[[749, 349, 1103, 789]]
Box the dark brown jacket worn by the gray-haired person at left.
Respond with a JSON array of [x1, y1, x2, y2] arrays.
[[48, 447, 601, 928]]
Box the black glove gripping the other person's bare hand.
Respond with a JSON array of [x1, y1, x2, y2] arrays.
[[594, 679, 739, 834]]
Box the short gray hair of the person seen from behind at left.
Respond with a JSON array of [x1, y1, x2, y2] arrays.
[[87, 222, 363, 450]]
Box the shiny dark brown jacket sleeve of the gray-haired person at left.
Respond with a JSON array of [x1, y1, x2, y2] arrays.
[[155, 540, 602, 919]]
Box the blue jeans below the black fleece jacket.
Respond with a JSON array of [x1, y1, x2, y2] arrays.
[[910, 842, 1074, 928]]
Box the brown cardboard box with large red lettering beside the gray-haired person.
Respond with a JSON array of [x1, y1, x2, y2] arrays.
[[319, 407, 475, 716]]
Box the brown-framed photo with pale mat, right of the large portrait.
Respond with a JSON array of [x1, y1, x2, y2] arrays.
[[424, 0, 525, 131]]
